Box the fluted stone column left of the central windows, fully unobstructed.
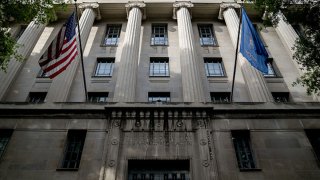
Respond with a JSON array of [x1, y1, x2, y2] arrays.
[[113, 1, 146, 102]]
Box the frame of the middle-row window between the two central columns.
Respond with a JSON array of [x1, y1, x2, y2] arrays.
[[149, 57, 170, 77]]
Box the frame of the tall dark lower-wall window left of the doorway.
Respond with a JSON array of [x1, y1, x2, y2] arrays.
[[57, 129, 87, 171]]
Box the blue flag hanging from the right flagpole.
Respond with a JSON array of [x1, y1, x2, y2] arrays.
[[240, 8, 268, 74]]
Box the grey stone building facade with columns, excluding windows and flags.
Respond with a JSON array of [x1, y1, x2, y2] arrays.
[[0, 0, 320, 180]]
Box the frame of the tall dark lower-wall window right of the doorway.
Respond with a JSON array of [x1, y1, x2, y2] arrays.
[[231, 130, 261, 171]]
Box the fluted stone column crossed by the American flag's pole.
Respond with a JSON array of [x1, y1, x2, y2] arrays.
[[46, 3, 100, 102]]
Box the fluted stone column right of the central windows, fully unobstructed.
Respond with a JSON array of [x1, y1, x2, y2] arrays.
[[173, 2, 205, 102]]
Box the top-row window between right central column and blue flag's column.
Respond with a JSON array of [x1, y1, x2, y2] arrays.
[[198, 24, 217, 46]]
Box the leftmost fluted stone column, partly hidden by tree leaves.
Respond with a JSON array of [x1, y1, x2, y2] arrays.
[[0, 21, 45, 101]]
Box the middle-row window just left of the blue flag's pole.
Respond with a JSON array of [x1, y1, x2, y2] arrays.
[[204, 58, 225, 77]]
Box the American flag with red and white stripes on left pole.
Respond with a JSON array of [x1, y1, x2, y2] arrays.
[[39, 13, 78, 79]]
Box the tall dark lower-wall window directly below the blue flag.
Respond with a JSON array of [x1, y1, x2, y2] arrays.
[[231, 130, 257, 170]]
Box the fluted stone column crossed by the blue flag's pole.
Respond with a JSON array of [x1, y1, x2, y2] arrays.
[[219, 3, 273, 102]]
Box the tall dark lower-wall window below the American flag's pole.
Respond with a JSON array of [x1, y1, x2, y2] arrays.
[[60, 130, 87, 169]]
